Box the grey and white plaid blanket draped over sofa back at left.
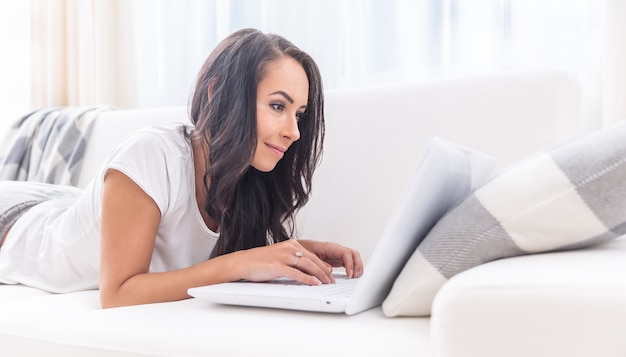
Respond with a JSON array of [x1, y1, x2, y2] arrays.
[[0, 106, 112, 186]]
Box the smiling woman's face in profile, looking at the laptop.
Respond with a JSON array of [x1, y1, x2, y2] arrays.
[[252, 56, 309, 172]]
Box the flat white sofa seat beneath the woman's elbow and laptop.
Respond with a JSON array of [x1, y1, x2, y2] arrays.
[[0, 291, 430, 357]]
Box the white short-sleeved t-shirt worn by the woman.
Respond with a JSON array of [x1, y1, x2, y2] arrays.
[[0, 124, 219, 292]]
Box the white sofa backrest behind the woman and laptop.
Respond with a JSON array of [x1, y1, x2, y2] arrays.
[[79, 71, 581, 260]]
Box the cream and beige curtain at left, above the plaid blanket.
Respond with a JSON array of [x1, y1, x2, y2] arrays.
[[30, 0, 135, 108]]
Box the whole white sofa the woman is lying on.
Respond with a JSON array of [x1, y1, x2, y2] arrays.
[[0, 71, 626, 357]]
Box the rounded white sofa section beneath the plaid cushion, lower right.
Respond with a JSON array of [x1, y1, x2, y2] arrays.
[[431, 237, 626, 357]]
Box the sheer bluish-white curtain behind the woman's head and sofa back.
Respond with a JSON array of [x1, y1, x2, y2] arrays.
[[123, 0, 608, 128]]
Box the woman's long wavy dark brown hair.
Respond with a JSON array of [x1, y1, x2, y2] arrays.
[[190, 29, 324, 256]]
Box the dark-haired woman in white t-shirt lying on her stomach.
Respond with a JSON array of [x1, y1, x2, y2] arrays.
[[0, 29, 363, 307]]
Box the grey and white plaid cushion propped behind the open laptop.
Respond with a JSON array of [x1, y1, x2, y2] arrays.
[[383, 123, 626, 316]]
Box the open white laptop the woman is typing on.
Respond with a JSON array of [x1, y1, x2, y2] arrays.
[[188, 138, 495, 315]]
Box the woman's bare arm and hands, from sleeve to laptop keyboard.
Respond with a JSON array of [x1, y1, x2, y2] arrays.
[[100, 169, 362, 308]]
